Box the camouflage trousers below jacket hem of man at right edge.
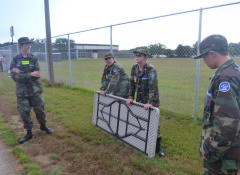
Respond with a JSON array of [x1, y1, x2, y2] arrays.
[[204, 160, 238, 175]]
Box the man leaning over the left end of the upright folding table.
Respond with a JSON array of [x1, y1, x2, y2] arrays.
[[100, 53, 129, 98]]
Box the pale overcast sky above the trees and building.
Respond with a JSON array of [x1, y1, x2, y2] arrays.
[[0, 0, 240, 50]]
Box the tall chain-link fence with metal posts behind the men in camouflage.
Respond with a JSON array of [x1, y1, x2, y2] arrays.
[[0, 3, 240, 117]]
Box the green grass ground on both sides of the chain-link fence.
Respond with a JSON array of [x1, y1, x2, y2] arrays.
[[0, 59, 240, 175]]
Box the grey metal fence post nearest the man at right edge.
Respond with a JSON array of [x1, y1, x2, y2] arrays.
[[194, 8, 202, 120]]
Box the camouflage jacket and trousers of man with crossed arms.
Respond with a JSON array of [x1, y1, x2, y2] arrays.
[[10, 54, 46, 130]]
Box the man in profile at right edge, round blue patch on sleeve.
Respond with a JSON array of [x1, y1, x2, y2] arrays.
[[196, 35, 240, 175]]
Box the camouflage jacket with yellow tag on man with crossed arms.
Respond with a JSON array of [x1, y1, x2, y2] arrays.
[[10, 54, 42, 97]]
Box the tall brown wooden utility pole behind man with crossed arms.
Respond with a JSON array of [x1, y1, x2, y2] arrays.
[[44, 0, 54, 85]]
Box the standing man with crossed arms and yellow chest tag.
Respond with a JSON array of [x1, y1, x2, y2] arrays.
[[10, 37, 53, 144]]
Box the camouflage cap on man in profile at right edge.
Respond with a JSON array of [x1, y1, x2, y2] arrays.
[[194, 35, 228, 59]]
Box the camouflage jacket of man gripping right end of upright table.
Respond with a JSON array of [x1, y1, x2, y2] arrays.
[[129, 63, 160, 107]]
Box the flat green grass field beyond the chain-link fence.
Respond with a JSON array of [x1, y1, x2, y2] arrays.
[[41, 58, 214, 118]]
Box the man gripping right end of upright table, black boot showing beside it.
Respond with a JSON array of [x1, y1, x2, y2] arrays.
[[127, 49, 165, 157]]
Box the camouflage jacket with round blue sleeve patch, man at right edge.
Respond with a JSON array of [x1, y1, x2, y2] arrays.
[[200, 60, 240, 169]]
